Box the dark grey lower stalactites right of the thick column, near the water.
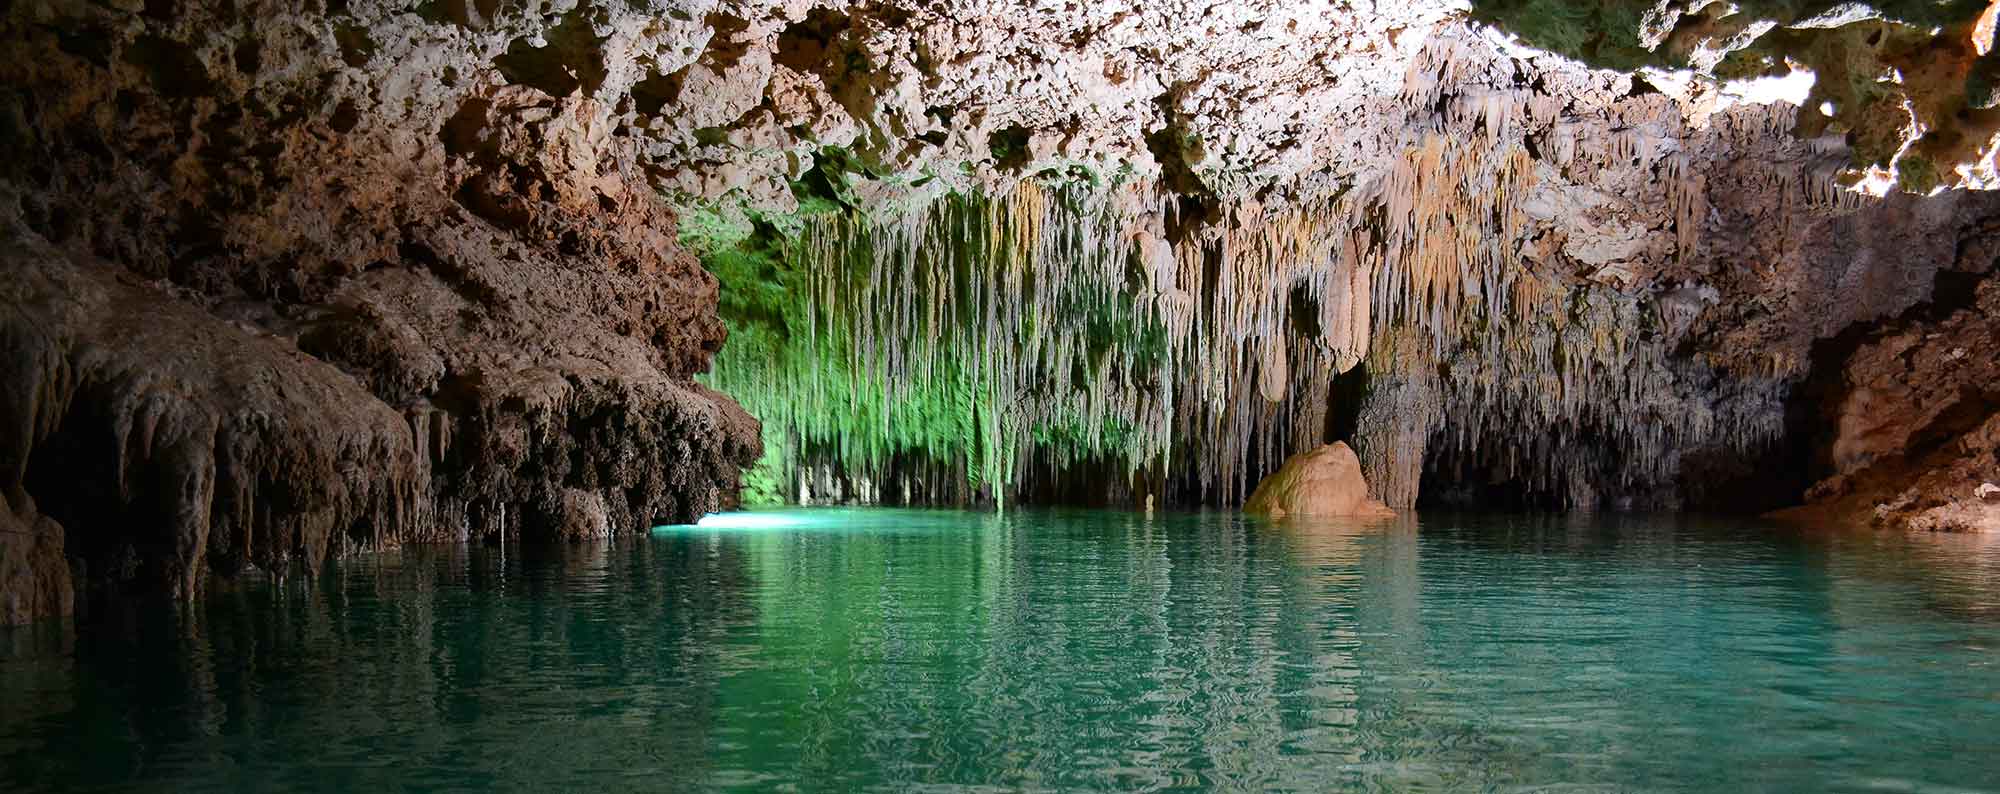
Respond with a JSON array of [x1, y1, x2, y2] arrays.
[[1400, 288, 1784, 508]]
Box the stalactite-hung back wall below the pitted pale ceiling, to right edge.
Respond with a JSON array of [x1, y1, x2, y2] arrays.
[[704, 22, 2000, 508]]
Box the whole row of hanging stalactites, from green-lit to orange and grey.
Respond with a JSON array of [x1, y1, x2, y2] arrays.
[[714, 68, 1852, 504]]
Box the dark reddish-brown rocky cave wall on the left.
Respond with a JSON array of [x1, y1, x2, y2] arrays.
[[0, 0, 758, 622]]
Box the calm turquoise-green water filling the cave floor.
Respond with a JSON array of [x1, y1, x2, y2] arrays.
[[0, 510, 2000, 792]]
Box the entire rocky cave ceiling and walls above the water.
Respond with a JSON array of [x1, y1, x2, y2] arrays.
[[0, 0, 2000, 620]]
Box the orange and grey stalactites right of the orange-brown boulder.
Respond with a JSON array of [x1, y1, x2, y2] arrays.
[[1356, 94, 1862, 508]]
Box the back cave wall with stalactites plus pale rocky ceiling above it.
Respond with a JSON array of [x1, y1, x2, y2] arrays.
[[676, 4, 1996, 510]]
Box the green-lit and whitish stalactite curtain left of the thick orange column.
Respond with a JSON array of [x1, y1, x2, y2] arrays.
[[708, 180, 1408, 500]]
